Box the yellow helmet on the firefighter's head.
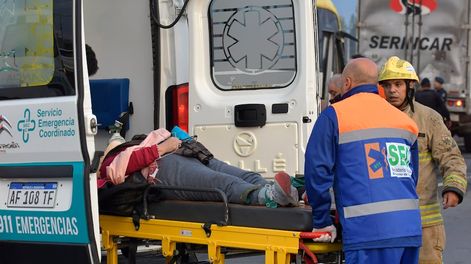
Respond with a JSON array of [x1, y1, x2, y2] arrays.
[[378, 56, 419, 82]]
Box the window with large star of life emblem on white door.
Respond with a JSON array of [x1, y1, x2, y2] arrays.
[[209, 0, 296, 90]]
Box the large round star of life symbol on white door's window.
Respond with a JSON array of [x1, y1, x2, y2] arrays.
[[223, 6, 284, 73]]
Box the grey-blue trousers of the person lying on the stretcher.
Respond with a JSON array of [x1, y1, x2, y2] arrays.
[[156, 154, 268, 204]]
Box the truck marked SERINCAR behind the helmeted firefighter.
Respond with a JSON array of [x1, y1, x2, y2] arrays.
[[357, 0, 471, 152]]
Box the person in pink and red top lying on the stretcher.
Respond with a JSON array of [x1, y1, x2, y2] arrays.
[[98, 129, 298, 207]]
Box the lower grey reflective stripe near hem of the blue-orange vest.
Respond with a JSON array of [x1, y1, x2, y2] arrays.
[[343, 199, 419, 218]]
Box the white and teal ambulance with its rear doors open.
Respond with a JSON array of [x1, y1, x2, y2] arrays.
[[0, 0, 346, 264]]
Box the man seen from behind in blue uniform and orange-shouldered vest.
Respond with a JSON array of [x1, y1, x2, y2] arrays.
[[304, 58, 422, 264]]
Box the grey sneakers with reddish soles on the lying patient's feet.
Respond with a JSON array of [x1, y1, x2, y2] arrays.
[[260, 172, 299, 208]]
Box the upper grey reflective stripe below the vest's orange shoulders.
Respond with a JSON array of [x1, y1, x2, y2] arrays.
[[339, 128, 417, 144]]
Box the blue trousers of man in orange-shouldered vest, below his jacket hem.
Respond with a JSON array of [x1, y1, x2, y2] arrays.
[[345, 247, 419, 264]]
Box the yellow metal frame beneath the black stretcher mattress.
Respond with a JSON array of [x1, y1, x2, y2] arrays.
[[100, 215, 342, 264]]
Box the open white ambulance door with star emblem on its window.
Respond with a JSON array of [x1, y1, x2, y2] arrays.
[[183, 0, 319, 178]]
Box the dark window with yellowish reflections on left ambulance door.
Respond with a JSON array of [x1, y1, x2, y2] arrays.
[[0, 0, 75, 100]]
